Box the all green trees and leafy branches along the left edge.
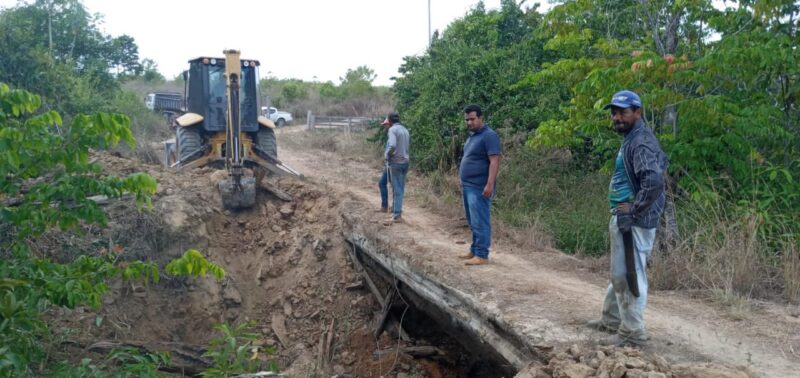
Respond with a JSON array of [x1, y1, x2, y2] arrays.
[[0, 0, 224, 377]]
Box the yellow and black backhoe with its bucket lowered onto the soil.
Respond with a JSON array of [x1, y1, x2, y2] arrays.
[[172, 50, 300, 209]]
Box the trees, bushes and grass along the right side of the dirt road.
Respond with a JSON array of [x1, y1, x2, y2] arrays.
[[393, 0, 800, 300]]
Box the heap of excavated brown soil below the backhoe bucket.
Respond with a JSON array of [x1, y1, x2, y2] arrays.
[[42, 153, 463, 377]]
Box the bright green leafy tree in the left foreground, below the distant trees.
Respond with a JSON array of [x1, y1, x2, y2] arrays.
[[0, 83, 158, 376]]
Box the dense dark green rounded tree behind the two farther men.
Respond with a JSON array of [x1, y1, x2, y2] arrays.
[[393, 0, 544, 170]]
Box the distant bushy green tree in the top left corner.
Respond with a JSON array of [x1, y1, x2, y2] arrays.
[[0, 0, 153, 118]]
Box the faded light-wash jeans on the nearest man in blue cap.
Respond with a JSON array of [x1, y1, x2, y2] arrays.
[[602, 215, 656, 341]]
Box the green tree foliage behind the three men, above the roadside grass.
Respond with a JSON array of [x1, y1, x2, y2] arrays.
[[393, 0, 800, 239]]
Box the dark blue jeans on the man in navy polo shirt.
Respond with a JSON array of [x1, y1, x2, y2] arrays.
[[461, 183, 494, 259]]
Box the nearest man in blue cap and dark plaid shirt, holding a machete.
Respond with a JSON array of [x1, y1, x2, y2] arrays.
[[587, 90, 667, 347]]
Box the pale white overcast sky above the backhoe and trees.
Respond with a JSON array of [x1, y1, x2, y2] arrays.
[[0, 0, 552, 85]]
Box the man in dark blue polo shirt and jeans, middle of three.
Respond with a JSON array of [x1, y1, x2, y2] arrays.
[[458, 105, 502, 265]]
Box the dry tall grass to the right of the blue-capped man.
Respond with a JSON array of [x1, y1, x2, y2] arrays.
[[650, 196, 800, 304]]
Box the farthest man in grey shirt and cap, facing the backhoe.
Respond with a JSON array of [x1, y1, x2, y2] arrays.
[[383, 112, 410, 226]]
